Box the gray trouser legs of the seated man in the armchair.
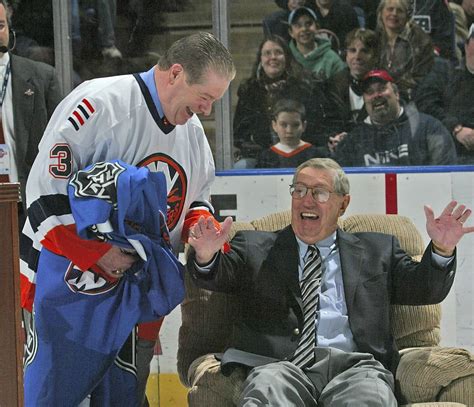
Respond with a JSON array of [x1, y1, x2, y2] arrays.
[[239, 348, 397, 407]]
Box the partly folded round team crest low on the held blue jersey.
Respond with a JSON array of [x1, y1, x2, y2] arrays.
[[64, 263, 120, 295]]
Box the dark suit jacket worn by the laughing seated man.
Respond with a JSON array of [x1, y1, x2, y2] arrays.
[[187, 227, 455, 372]]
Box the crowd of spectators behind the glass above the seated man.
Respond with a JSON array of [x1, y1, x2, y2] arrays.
[[233, 0, 474, 168]]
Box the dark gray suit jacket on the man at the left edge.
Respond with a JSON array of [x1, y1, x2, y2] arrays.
[[10, 54, 62, 206]]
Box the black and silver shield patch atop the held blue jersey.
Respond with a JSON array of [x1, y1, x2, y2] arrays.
[[70, 162, 125, 206]]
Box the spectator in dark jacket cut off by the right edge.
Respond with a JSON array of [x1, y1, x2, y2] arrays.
[[443, 24, 474, 164]]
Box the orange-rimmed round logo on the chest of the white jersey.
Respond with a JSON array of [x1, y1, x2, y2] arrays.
[[137, 153, 188, 231]]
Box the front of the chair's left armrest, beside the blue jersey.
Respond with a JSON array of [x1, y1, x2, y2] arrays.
[[188, 354, 247, 407]]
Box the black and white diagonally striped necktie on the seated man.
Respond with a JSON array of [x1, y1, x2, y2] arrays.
[[292, 246, 322, 369]]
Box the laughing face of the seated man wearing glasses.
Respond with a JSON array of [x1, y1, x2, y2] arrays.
[[291, 167, 350, 244]]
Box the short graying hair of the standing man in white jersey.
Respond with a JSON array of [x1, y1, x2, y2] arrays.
[[158, 32, 235, 85]]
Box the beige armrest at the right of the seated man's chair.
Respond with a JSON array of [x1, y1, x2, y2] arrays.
[[396, 347, 474, 406]]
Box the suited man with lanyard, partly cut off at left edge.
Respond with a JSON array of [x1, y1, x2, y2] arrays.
[[0, 0, 62, 224]]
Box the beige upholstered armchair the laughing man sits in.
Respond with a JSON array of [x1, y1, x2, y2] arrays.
[[178, 211, 474, 407]]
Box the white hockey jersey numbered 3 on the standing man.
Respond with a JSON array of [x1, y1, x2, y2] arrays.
[[21, 74, 215, 309]]
